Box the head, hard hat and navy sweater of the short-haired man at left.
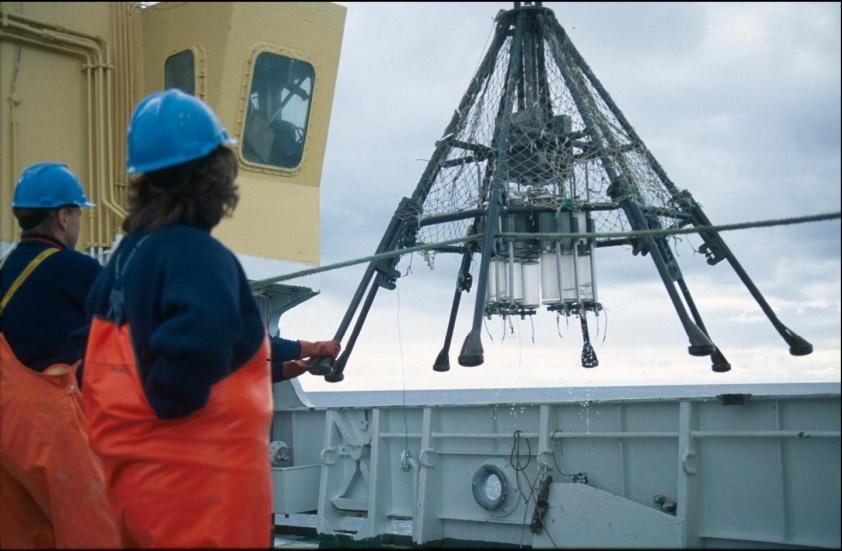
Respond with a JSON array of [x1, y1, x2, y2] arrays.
[[0, 163, 101, 378]]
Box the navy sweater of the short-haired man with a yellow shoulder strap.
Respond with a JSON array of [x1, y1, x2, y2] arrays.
[[0, 235, 101, 372]]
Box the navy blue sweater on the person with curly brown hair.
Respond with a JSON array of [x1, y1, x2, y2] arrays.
[[87, 225, 301, 419]]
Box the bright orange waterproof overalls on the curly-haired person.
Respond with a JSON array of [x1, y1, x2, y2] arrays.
[[84, 318, 272, 548]]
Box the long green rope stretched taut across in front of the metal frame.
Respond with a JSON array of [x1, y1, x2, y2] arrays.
[[246, 212, 842, 291]]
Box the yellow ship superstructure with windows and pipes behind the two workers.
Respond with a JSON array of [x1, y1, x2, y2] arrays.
[[0, 2, 345, 265]]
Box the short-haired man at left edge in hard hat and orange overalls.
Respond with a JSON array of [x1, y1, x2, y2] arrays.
[[0, 163, 120, 549]]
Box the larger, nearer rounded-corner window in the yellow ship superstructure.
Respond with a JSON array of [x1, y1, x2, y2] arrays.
[[242, 52, 315, 168]]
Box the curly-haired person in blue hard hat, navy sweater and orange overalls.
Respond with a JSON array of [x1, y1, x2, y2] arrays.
[[83, 90, 339, 548]]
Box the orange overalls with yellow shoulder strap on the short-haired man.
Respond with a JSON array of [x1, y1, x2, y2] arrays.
[[0, 248, 120, 549]]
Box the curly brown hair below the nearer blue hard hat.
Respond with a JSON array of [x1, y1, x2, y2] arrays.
[[123, 146, 240, 233]]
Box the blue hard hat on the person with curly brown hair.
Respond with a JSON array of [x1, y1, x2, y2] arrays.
[[126, 89, 237, 174]]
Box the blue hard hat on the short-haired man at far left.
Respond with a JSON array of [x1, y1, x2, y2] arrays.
[[12, 163, 94, 209]]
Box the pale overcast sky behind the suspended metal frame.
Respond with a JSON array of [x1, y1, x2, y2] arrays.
[[262, 2, 840, 390]]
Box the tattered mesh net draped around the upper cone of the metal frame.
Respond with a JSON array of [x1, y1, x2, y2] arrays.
[[410, 15, 683, 265]]
